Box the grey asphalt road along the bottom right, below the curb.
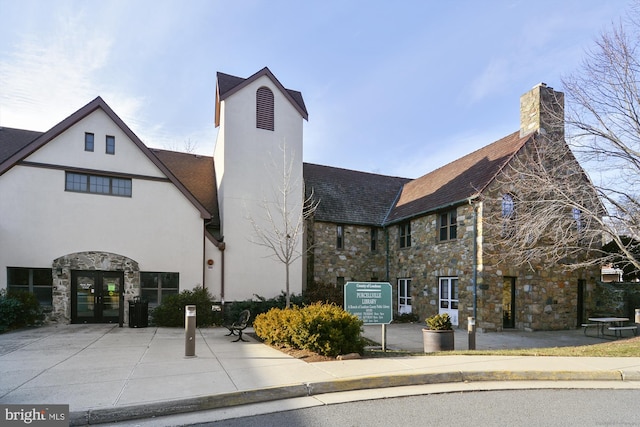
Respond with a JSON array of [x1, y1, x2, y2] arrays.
[[202, 389, 640, 427]]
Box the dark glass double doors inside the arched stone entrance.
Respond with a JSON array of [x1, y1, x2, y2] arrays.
[[71, 270, 124, 323]]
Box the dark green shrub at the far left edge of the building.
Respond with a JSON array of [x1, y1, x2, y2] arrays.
[[0, 290, 44, 332]]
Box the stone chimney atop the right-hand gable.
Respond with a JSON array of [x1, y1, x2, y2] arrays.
[[520, 83, 564, 139]]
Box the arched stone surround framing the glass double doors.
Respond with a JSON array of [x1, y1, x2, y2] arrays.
[[49, 251, 140, 323]]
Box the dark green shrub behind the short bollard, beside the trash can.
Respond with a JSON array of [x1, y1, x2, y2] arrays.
[[151, 287, 215, 327]]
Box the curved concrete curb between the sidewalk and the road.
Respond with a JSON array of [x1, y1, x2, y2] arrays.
[[69, 371, 624, 426]]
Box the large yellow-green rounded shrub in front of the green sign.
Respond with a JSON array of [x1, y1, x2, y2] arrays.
[[253, 303, 364, 357]]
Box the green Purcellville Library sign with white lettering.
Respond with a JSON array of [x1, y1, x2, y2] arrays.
[[344, 282, 393, 325]]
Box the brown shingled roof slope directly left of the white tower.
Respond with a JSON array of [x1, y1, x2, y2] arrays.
[[151, 148, 220, 227]]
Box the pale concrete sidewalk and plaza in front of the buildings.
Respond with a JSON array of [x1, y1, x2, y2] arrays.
[[0, 324, 640, 425]]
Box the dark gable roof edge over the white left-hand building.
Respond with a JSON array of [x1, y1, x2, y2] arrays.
[[0, 97, 215, 219]]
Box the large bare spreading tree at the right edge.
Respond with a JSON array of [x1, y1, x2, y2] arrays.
[[487, 2, 640, 271]]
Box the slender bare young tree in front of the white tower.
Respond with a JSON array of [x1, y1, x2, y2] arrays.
[[247, 144, 319, 308]]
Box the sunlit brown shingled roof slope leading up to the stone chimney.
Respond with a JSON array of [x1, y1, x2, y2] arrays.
[[387, 131, 535, 223]]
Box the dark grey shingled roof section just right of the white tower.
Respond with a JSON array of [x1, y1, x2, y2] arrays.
[[303, 163, 410, 225]]
